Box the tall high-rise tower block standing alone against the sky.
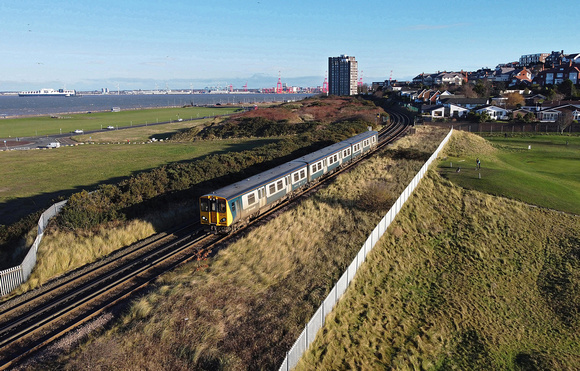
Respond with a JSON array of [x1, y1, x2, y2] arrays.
[[328, 55, 358, 95]]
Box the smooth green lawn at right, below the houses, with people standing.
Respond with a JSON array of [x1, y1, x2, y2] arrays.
[[439, 135, 580, 214]]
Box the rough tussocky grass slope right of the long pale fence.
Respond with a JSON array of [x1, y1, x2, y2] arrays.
[[298, 132, 580, 370]]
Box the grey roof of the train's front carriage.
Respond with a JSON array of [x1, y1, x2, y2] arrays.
[[206, 161, 306, 199]]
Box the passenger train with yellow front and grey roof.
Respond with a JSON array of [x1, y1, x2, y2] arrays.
[[199, 130, 378, 233]]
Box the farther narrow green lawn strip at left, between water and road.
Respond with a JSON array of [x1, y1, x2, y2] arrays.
[[0, 107, 239, 138]]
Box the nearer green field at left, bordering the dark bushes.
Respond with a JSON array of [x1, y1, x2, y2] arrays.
[[0, 139, 273, 224]]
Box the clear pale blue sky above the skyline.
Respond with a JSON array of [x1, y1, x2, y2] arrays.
[[0, 0, 580, 91]]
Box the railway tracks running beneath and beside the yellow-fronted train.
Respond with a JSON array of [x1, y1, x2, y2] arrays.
[[0, 111, 412, 370]]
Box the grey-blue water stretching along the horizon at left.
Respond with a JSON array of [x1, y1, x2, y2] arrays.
[[0, 93, 312, 118]]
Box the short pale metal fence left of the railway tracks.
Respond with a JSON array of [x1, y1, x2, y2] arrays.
[[0, 201, 66, 296]]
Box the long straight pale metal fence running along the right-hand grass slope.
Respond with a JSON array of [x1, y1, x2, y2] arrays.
[[279, 129, 453, 371]]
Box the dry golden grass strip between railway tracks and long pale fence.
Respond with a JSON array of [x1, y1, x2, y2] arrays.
[[31, 127, 446, 370]]
